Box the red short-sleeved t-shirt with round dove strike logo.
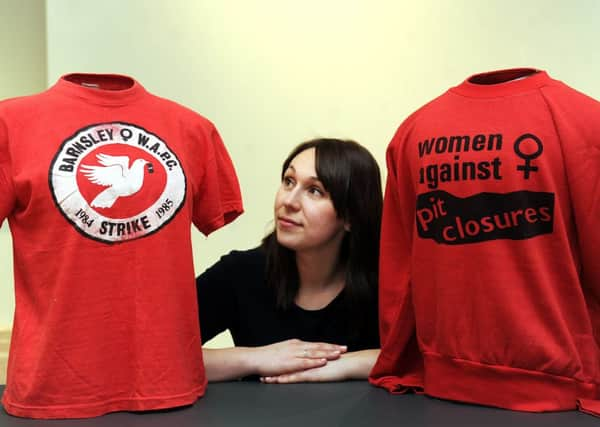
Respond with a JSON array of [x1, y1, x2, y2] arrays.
[[0, 74, 243, 418]]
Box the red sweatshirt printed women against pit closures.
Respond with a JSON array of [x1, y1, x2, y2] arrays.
[[370, 69, 600, 413]]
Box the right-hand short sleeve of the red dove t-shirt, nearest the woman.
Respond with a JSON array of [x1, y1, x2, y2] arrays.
[[193, 124, 244, 235]]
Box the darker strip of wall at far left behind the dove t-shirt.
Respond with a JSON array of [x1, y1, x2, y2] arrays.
[[0, 0, 46, 332]]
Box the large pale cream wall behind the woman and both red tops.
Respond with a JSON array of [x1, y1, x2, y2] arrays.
[[2, 0, 600, 338]]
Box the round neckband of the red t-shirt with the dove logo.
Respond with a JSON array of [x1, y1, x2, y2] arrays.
[[50, 73, 147, 106]]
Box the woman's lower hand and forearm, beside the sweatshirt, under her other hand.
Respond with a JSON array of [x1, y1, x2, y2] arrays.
[[260, 349, 379, 384]]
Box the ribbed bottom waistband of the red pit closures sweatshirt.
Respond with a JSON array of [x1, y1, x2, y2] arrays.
[[423, 353, 600, 412]]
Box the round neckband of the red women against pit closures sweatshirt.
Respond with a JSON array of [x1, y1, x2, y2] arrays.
[[450, 68, 553, 98]]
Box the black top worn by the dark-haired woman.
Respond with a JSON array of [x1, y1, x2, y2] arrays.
[[196, 247, 379, 351]]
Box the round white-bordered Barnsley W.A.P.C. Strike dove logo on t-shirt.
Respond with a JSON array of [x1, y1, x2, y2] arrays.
[[49, 122, 186, 243]]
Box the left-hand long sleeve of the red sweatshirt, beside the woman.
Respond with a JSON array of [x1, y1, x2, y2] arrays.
[[369, 126, 423, 393]]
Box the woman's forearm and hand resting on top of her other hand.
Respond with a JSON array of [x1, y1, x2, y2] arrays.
[[202, 339, 347, 381]]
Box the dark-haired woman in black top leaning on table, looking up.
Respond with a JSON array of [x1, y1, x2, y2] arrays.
[[196, 139, 382, 383]]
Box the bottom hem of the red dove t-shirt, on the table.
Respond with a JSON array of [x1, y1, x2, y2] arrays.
[[2, 386, 206, 419]]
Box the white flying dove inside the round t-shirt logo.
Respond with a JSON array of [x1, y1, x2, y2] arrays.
[[81, 154, 149, 208]]
